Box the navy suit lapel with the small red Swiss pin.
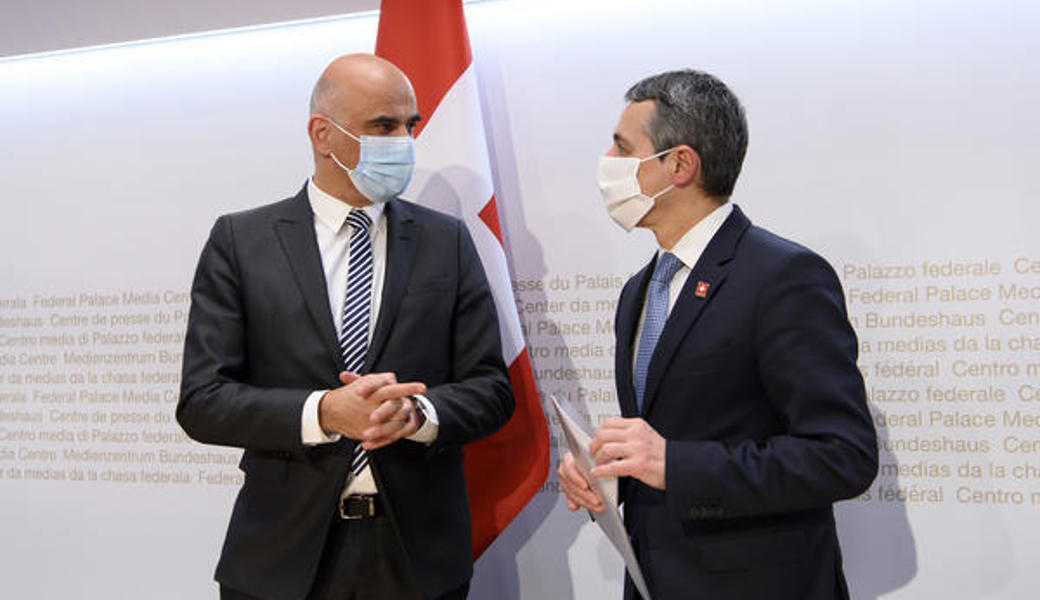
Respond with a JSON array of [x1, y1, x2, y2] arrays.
[[636, 206, 751, 415]]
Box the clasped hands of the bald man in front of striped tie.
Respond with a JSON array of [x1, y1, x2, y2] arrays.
[[318, 371, 426, 450]]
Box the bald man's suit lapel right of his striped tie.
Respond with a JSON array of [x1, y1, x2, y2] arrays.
[[362, 200, 419, 372]]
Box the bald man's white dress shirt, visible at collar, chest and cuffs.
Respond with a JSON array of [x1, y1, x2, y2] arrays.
[[301, 179, 438, 495]]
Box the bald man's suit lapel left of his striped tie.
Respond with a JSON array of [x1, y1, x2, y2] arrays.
[[275, 185, 340, 357]]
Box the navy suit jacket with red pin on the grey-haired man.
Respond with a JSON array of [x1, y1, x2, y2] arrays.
[[616, 207, 878, 600]]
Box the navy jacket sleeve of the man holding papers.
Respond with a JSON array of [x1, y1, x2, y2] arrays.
[[666, 251, 878, 518]]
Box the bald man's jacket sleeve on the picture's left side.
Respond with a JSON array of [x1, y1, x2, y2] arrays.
[[177, 216, 311, 451]]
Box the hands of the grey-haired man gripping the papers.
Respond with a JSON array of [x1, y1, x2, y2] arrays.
[[556, 417, 667, 513]]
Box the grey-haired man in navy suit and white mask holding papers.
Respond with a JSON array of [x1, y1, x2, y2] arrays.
[[558, 71, 878, 600]]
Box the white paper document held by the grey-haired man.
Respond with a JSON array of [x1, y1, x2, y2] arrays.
[[549, 395, 650, 600]]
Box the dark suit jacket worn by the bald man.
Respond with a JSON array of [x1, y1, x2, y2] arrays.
[[177, 187, 513, 600]]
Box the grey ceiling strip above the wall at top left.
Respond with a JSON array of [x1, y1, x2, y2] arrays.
[[0, 0, 380, 56]]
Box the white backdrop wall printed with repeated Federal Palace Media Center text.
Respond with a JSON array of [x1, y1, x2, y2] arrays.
[[0, 0, 1040, 600]]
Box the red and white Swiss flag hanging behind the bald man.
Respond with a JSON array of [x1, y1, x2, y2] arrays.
[[375, 0, 549, 559]]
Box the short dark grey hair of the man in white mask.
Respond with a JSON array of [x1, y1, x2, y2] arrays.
[[625, 69, 748, 198]]
